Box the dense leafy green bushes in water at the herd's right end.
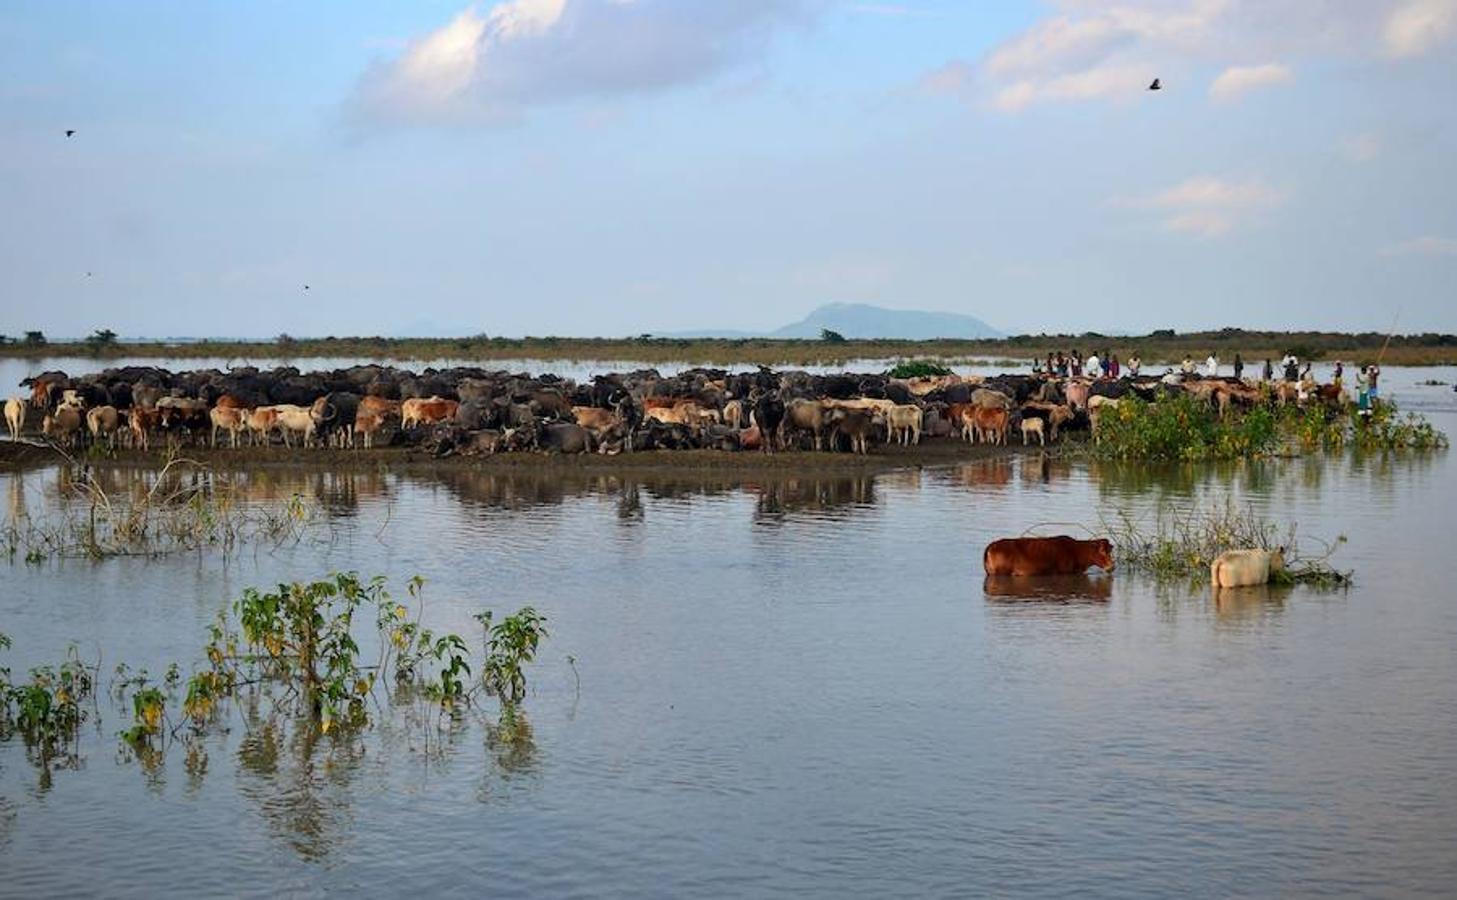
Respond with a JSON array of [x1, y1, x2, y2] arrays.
[[1091, 395, 1447, 460]]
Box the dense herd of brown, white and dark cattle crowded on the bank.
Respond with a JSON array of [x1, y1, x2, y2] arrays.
[[4, 359, 1334, 456]]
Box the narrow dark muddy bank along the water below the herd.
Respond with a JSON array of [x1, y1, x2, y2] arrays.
[[0, 438, 1064, 475]]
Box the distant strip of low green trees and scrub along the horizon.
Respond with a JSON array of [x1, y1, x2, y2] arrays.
[[0, 328, 1457, 366]]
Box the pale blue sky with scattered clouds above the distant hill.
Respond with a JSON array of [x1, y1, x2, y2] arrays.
[[0, 0, 1457, 336]]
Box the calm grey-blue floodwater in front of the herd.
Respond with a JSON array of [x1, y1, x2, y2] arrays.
[[0, 361, 1457, 897]]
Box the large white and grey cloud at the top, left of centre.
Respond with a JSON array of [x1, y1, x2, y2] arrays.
[[350, 0, 823, 127]]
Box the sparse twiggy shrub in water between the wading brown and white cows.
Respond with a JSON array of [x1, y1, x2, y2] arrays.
[[1100, 498, 1351, 588]]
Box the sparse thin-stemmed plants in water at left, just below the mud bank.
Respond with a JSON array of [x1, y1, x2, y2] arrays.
[[0, 459, 322, 562]]
